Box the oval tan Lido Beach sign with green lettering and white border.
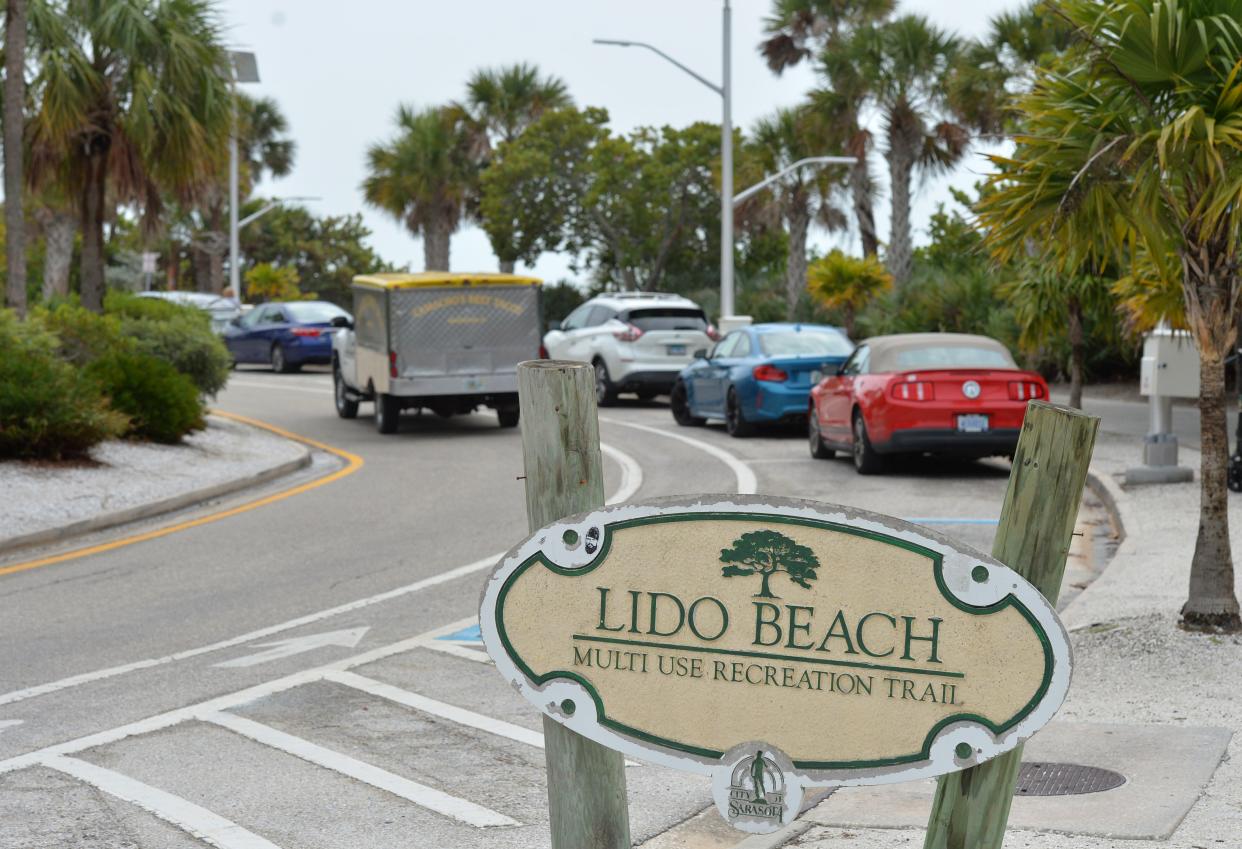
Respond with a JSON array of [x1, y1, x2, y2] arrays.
[[479, 495, 1071, 832]]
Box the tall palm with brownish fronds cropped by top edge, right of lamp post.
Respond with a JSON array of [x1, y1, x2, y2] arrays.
[[759, 0, 897, 256]]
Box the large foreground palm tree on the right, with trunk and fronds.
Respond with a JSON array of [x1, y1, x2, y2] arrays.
[[980, 0, 1242, 631]]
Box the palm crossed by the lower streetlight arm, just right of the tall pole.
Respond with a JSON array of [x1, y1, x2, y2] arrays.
[[743, 108, 843, 320]]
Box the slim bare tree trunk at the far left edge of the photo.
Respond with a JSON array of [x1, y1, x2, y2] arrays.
[[4, 0, 26, 315]]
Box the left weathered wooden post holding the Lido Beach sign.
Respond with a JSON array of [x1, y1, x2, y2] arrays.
[[518, 360, 630, 849]]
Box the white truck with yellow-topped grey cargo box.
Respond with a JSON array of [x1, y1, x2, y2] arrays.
[[332, 272, 543, 433]]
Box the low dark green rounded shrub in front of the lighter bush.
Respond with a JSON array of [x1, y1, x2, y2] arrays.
[[86, 351, 204, 443]]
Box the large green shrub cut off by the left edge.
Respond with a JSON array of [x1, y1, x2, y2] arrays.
[[0, 310, 129, 459]]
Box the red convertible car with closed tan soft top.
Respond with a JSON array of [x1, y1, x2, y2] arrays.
[[807, 333, 1048, 474]]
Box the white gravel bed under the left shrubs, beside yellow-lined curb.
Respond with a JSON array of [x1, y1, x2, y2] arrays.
[[0, 416, 306, 544]]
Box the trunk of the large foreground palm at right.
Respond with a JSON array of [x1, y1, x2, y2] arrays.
[[1181, 346, 1242, 631]]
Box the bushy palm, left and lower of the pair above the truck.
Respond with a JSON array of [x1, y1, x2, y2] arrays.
[[363, 106, 477, 271]]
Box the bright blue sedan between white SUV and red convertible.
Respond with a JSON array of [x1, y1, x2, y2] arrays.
[[671, 324, 854, 437]]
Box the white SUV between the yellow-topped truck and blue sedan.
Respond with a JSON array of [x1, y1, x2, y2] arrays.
[[544, 292, 719, 406]]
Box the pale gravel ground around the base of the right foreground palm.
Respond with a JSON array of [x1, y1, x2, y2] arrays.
[[786, 436, 1242, 849]]
